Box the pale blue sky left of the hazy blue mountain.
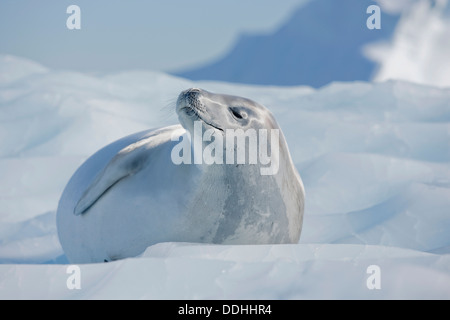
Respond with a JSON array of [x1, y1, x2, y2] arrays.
[[0, 0, 307, 73]]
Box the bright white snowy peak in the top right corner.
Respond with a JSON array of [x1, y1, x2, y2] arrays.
[[366, 0, 450, 87]]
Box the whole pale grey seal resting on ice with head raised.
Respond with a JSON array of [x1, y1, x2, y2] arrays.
[[57, 88, 304, 263]]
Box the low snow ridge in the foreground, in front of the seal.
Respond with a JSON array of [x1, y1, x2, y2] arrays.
[[0, 243, 450, 299]]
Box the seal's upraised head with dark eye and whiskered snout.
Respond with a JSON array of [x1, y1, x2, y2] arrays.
[[176, 88, 278, 134]]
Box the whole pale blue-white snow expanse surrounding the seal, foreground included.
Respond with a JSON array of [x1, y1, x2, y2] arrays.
[[0, 56, 450, 299]]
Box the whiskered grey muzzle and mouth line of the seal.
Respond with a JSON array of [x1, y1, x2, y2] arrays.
[[177, 89, 223, 132]]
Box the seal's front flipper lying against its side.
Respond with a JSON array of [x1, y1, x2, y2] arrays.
[[73, 137, 152, 216]]
